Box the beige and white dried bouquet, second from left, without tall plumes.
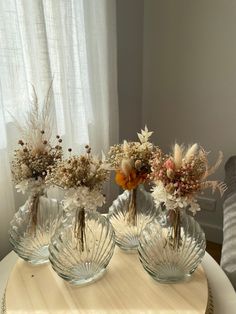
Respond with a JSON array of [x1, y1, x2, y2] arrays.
[[46, 145, 109, 251]]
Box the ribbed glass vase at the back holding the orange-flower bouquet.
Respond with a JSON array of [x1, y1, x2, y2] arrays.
[[108, 184, 158, 253]]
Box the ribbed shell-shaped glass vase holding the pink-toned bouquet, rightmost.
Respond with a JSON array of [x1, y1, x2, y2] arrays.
[[138, 208, 206, 283]]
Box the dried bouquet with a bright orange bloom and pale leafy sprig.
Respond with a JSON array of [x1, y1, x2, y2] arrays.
[[107, 126, 158, 225]]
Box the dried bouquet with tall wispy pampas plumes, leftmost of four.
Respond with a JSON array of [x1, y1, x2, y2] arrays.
[[11, 85, 62, 232]]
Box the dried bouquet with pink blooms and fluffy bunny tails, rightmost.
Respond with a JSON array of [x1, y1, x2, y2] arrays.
[[149, 144, 227, 247]]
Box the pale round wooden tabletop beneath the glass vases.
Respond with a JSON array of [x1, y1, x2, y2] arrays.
[[6, 248, 208, 314]]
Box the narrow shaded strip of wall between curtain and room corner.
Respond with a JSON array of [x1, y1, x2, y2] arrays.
[[116, 0, 144, 141]]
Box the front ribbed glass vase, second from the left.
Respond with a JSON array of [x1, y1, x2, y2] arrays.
[[49, 208, 115, 286]]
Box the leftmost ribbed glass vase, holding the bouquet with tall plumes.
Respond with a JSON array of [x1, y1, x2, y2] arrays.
[[9, 189, 61, 265]]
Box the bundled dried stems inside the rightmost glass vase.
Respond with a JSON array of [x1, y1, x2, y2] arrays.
[[168, 209, 182, 250]]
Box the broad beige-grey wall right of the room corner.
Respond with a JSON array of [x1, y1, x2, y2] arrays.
[[142, 0, 236, 242]]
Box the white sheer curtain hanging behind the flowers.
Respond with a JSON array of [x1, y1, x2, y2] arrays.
[[0, 0, 118, 258]]
